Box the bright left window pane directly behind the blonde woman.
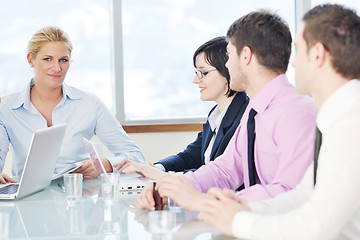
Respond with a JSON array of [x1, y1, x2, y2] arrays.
[[0, 0, 115, 111]]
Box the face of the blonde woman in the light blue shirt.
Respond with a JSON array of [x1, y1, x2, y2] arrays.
[[27, 42, 70, 88]]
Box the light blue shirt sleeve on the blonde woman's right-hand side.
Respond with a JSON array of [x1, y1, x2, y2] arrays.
[[94, 96, 145, 165]]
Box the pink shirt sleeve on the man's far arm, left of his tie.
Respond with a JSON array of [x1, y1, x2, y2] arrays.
[[184, 126, 243, 192]]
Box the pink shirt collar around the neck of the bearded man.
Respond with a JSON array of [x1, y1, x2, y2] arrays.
[[249, 74, 291, 114]]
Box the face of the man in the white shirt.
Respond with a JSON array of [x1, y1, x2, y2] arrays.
[[292, 24, 313, 94]]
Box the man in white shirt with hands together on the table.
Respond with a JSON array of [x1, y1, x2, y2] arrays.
[[199, 5, 360, 240]]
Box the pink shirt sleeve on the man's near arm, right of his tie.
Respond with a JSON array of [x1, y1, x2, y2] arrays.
[[237, 105, 316, 201]]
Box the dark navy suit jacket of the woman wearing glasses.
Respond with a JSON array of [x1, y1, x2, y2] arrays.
[[157, 92, 249, 172]]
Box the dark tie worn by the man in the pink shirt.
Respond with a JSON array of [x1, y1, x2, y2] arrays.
[[247, 108, 257, 186]]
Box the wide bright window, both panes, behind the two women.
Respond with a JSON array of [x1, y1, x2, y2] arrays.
[[0, 0, 298, 125]]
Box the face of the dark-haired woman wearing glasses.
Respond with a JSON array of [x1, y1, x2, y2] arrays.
[[193, 52, 227, 103]]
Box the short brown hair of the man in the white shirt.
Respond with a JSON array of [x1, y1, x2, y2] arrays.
[[303, 4, 360, 79]]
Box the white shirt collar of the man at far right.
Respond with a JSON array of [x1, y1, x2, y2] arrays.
[[316, 79, 360, 132]]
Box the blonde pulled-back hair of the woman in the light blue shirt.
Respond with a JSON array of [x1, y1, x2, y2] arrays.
[[27, 26, 73, 58]]
